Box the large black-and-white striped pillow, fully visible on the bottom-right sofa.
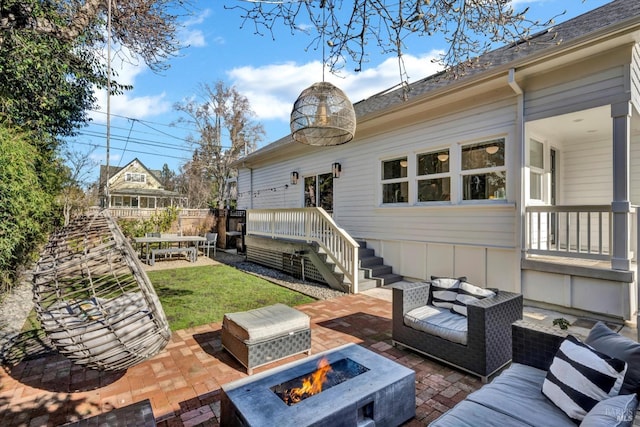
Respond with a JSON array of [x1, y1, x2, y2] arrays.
[[542, 335, 627, 424]]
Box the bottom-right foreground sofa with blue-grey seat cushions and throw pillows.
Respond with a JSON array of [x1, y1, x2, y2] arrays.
[[430, 321, 640, 427]]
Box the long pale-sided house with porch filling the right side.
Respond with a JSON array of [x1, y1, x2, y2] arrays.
[[236, 0, 640, 319]]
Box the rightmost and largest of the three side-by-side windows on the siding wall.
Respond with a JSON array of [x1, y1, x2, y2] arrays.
[[461, 138, 507, 200]]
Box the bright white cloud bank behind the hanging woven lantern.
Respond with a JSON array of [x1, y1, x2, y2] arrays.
[[227, 51, 439, 122]]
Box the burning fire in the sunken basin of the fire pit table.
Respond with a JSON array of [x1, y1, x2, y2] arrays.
[[271, 357, 369, 406]]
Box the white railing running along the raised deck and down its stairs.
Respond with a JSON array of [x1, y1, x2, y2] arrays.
[[247, 208, 359, 293]]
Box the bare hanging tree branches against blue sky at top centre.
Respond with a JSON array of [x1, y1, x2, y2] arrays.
[[225, 0, 555, 77]]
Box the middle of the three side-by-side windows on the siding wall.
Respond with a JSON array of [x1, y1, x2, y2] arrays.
[[416, 150, 451, 202]]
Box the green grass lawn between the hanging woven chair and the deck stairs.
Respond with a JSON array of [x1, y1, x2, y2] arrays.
[[147, 265, 315, 331]]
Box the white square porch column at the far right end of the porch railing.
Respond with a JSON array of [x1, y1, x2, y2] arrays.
[[611, 102, 632, 270]]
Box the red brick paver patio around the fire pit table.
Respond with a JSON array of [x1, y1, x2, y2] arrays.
[[0, 294, 482, 427]]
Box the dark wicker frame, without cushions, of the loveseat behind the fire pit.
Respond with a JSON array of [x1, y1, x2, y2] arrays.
[[392, 283, 522, 382]]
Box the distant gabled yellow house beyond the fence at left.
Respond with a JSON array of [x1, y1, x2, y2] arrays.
[[99, 158, 187, 210]]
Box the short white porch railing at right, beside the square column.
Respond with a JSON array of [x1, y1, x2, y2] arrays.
[[525, 205, 612, 260]]
